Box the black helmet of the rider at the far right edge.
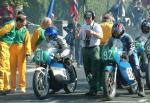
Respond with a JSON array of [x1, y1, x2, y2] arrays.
[[141, 20, 150, 34]]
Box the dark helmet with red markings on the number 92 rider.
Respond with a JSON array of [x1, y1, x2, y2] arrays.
[[112, 23, 125, 38]]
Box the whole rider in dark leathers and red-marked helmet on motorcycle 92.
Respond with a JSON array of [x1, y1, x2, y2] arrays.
[[108, 23, 145, 97]]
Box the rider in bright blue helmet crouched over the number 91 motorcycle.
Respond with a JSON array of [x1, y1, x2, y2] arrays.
[[38, 27, 70, 58]]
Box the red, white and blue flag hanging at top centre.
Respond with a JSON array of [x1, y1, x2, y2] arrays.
[[70, 0, 78, 22]]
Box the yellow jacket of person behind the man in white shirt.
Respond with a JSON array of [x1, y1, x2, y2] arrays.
[[100, 22, 113, 45]]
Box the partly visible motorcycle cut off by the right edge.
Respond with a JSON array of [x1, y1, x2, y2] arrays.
[[135, 37, 150, 89]]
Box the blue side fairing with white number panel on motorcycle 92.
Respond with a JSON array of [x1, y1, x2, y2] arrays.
[[114, 54, 135, 85]]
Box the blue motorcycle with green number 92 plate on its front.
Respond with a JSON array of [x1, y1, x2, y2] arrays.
[[102, 45, 137, 100]]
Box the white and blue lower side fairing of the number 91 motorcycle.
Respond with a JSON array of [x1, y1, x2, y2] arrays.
[[51, 62, 70, 83]]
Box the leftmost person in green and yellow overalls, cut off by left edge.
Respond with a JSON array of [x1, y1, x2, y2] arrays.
[[0, 12, 24, 95]]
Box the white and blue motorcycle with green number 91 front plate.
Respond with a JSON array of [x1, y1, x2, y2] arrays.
[[33, 49, 77, 99]]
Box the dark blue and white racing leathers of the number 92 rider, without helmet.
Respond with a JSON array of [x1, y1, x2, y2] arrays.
[[108, 33, 145, 97]]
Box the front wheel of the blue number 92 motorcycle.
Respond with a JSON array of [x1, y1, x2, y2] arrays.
[[103, 71, 116, 100]]
